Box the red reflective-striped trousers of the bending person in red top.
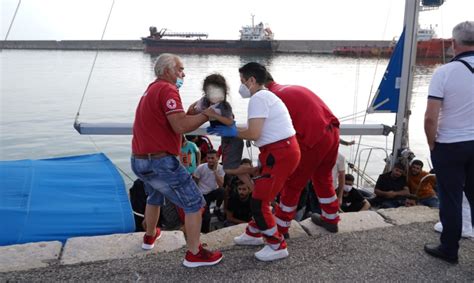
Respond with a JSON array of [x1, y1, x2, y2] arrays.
[[275, 125, 339, 234]]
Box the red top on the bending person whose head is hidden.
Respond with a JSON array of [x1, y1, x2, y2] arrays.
[[268, 82, 339, 149]]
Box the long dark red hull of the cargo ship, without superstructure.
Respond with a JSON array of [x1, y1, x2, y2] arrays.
[[142, 38, 273, 54]]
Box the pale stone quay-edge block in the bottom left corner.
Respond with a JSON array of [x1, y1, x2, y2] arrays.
[[0, 241, 62, 272]]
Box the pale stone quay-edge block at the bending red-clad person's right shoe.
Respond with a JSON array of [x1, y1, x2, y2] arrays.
[[300, 211, 392, 236]]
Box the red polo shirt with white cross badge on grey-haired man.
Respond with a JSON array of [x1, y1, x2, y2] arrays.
[[132, 80, 184, 155]]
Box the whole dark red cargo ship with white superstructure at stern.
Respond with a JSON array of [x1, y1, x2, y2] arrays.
[[142, 15, 274, 54]]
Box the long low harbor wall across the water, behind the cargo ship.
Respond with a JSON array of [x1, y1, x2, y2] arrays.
[[0, 40, 390, 54]]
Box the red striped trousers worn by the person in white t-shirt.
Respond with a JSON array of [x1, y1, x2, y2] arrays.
[[246, 136, 300, 249]]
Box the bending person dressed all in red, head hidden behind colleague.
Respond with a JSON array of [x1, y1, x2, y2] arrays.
[[265, 72, 339, 235]]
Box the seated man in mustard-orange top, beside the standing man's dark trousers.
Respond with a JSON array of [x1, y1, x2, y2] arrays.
[[408, 160, 439, 208]]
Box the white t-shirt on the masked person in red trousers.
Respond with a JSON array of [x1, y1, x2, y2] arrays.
[[248, 90, 296, 147]]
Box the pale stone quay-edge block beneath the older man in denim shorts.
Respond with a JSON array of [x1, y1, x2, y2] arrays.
[[61, 231, 186, 264]]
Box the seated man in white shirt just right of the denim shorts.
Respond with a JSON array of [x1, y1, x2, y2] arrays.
[[193, 149, 225, 233]]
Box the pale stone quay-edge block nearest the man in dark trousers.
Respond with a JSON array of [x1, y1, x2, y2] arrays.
[[377, 205, 439, 225]]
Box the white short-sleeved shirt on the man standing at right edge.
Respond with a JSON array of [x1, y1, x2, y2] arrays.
[[428, 56, 474, 143]]
